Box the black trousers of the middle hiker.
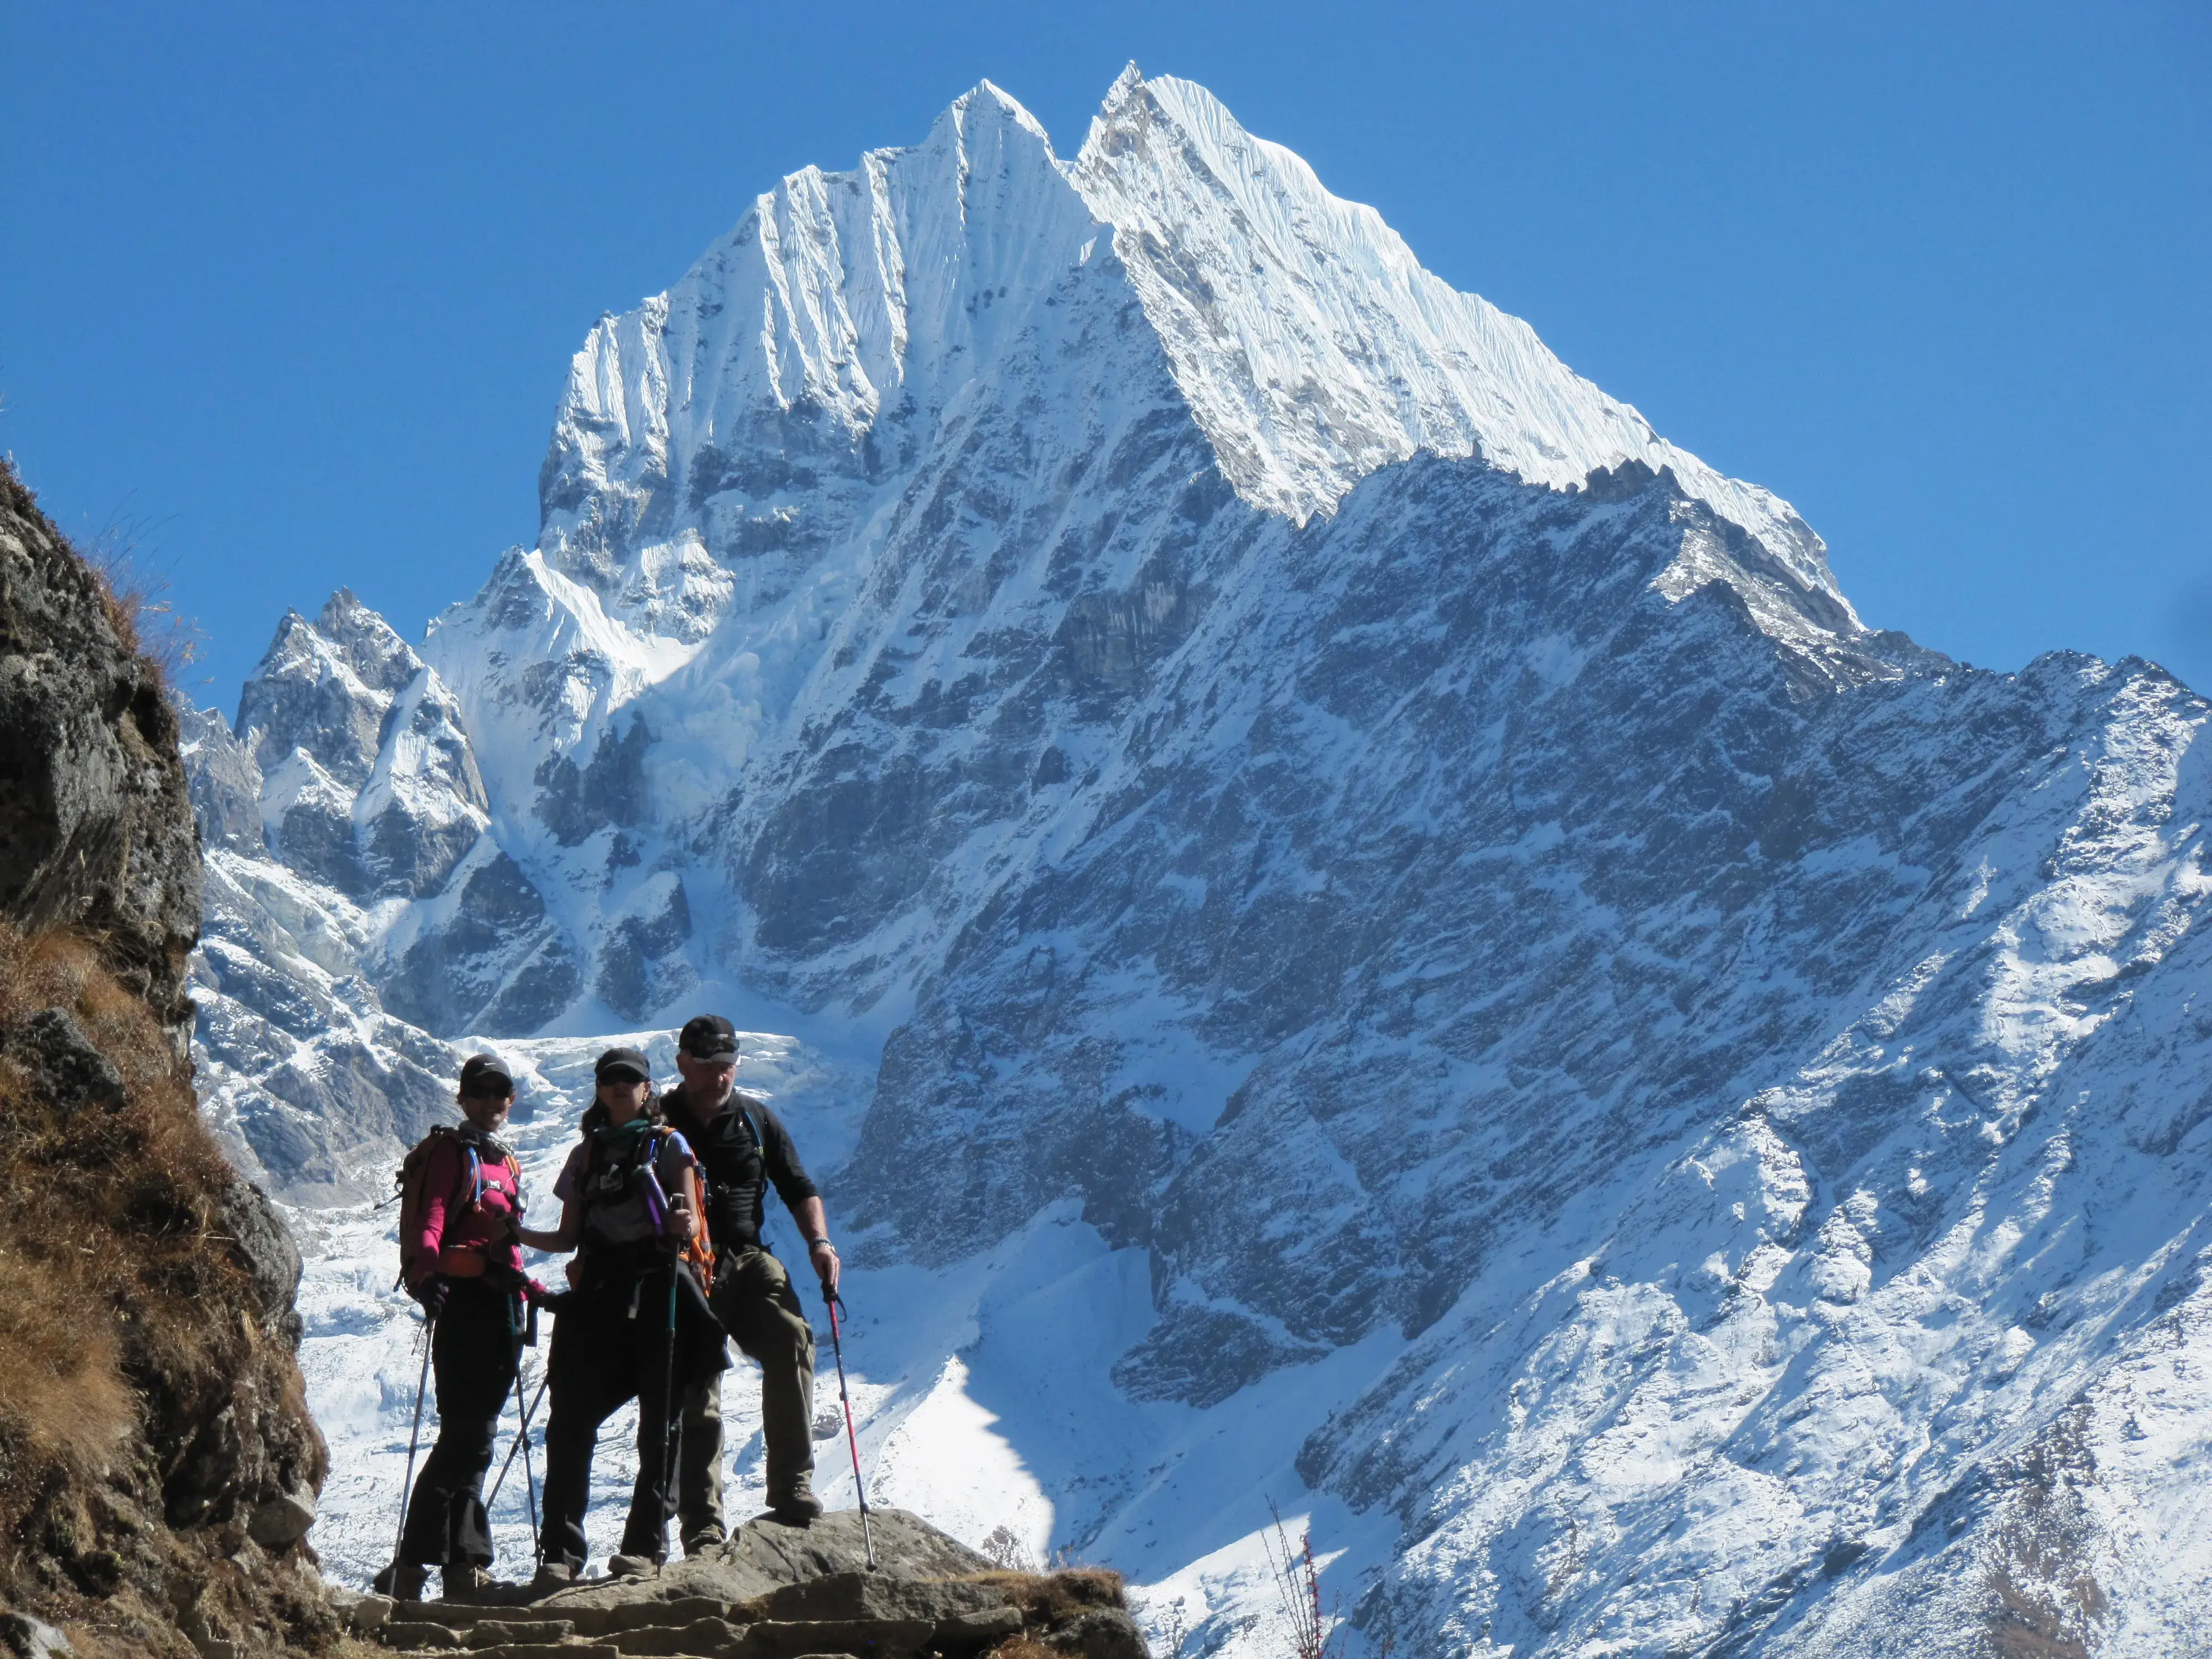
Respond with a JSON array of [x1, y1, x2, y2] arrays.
[[540, 1267, 726, 1573]]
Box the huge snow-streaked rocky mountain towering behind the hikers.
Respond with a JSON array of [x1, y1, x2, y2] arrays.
[[188, 73, 2212, 1655]]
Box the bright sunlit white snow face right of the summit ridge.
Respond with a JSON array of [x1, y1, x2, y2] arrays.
[[1068, 64, 1856, 597]]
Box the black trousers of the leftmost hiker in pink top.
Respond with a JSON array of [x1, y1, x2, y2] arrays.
[[400, 1279, 522, 1568]]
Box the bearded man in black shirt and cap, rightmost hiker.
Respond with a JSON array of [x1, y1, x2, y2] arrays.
[[661, 1013, 838, 1555]]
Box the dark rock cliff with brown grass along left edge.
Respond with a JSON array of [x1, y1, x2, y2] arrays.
[[0, 469, 334, 1659]]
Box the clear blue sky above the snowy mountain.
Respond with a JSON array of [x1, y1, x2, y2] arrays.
[[0, 0, 2212, 712]]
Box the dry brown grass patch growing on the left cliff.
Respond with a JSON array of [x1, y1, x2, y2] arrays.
[[0, 925, 243, 1544]]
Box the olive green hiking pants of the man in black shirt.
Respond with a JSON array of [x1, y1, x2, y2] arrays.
[[677, 1248, 814, 1544]]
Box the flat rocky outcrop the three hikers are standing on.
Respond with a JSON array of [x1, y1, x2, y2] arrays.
[[336, 1509, 1146, 1659]]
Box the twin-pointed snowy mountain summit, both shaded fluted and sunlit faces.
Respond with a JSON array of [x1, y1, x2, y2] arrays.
[[526, 64, 1858, 672]]
